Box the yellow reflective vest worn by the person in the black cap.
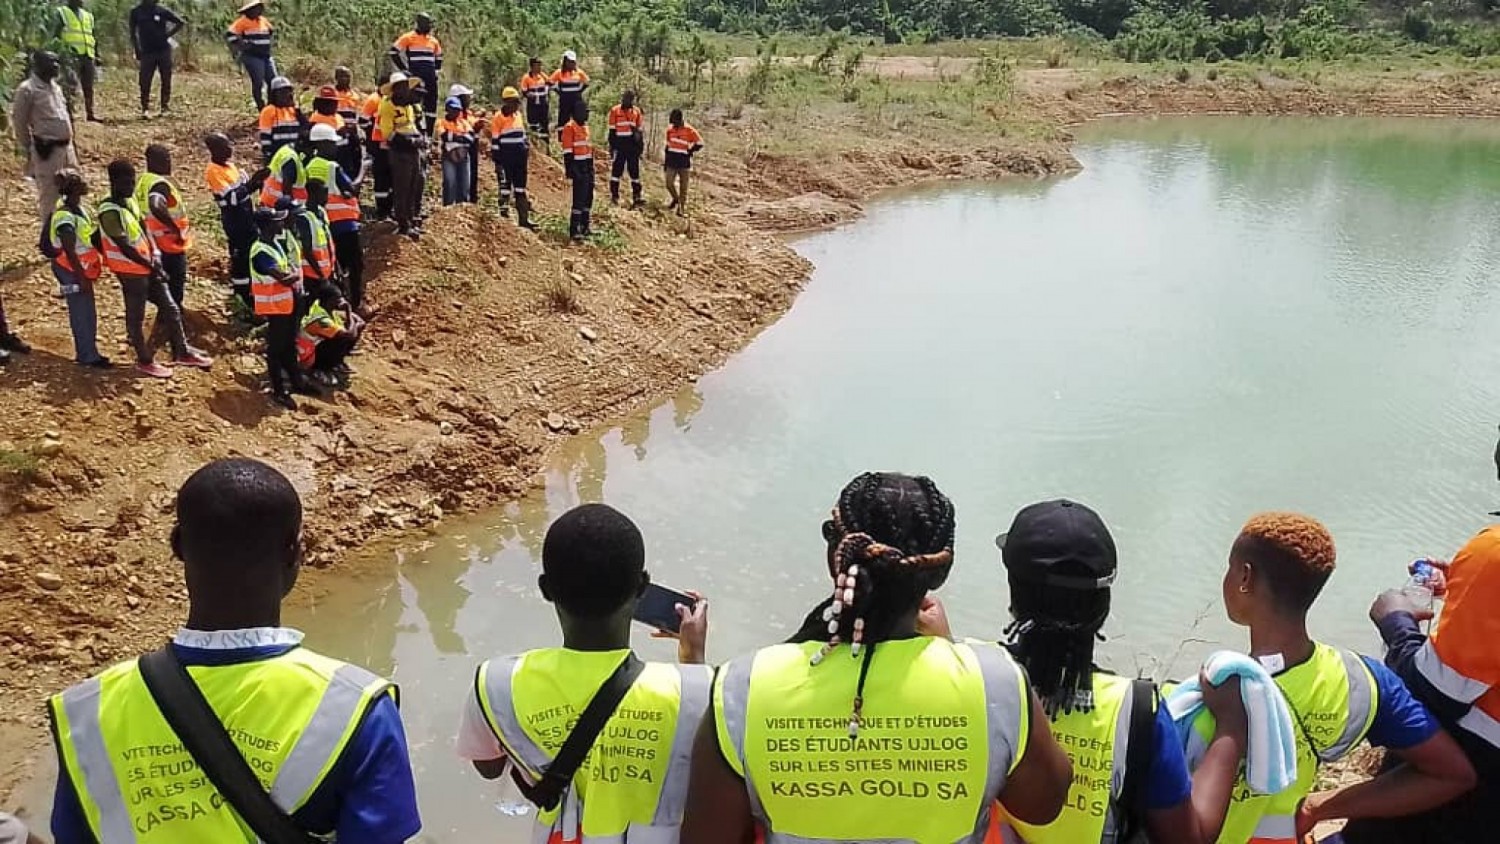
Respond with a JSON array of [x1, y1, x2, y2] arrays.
[[1007, 672, 1134, 844]]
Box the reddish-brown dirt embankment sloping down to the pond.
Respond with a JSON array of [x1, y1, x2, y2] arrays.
[[0, 64, 1500, 805]]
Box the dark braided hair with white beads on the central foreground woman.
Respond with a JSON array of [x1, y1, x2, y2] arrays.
[[803, 472, 954, 736]]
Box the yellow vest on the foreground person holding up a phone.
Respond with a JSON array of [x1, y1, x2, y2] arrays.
[[474, 648, 713, 844]]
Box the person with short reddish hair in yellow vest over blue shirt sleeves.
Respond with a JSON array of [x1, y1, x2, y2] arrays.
[[1188, 513, 1475, 844]]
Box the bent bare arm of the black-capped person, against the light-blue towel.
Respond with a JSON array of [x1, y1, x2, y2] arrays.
[[1146, 678, 1250, 844]]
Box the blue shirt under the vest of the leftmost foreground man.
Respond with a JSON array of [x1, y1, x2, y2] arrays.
[[53, 643, 422, 844]]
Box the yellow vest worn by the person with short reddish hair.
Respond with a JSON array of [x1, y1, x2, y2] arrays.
[[1187, 643, 1380, 844]]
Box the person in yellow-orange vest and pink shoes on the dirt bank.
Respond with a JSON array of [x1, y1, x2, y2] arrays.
[[98, 159, 213, 378]]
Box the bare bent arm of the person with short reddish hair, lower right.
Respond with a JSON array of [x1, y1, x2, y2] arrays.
[[1298, 733, 1479, 837]]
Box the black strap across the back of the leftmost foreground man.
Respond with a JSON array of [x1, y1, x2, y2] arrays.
[[138, 645, 315, 844]]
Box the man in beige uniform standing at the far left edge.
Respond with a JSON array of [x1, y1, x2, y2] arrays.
[[11, 51, 78, 225]]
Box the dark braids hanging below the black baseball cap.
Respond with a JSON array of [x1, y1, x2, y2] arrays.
[[1005, 565, 1110, 718]]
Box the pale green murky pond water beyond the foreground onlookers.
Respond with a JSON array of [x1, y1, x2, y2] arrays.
[[291, 118, 1500, 841]]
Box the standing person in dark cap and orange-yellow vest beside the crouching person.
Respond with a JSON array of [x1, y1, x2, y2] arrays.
[[251, 202, 305, 411]]
